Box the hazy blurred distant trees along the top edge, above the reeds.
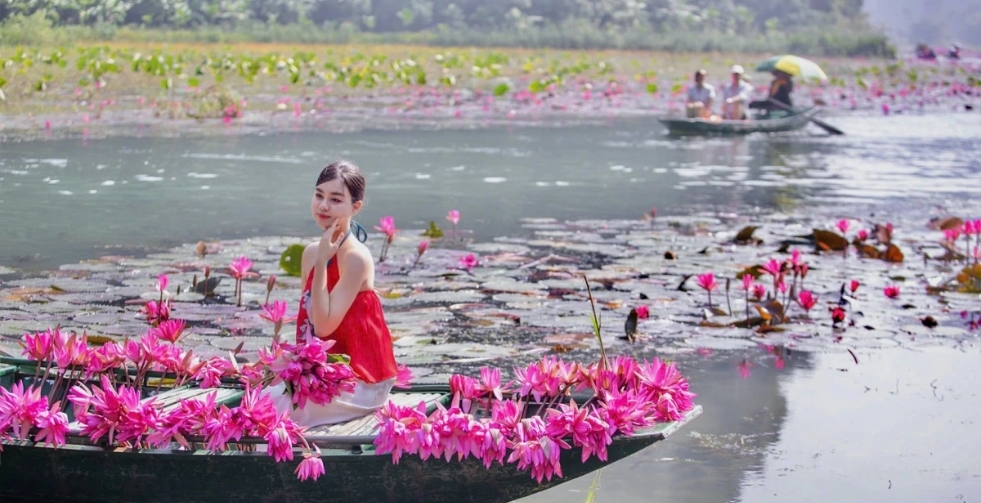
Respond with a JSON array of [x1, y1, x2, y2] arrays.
[[0, 0, 862, 33]]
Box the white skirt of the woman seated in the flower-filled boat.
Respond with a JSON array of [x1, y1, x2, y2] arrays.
[[266, 377, 395, 428]]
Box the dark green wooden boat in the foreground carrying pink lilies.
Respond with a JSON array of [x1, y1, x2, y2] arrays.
[[0, 359, 701, 503]]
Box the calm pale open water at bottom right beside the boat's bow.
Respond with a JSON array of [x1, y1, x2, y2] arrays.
[[521, 345, 981, 503]]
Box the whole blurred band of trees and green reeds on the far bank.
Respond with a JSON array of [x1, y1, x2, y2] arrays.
[[0, 0, 895, 57]]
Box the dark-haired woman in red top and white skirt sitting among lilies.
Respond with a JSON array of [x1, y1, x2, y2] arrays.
[[270, 160, 398, 427]]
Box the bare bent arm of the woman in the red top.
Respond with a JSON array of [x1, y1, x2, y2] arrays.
[[308, 251, 368, 339]]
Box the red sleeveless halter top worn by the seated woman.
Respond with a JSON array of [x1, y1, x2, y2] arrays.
[[296, 260, 398, 383]]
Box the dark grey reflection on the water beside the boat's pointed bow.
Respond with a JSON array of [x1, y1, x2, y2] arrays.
[[521, 347, 813, 503]]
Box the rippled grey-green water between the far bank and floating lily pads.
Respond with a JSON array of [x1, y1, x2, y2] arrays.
[[0, 114, 981, 269]]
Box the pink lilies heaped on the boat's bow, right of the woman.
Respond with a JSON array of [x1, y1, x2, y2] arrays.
[[375, 356, 695, 482]]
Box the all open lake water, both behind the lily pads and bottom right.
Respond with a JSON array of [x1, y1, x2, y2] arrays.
[[0, 113, 981, 503]]
